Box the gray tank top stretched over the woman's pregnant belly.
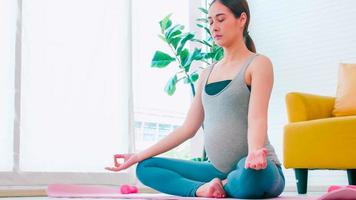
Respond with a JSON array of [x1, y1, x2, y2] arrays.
[[202, 54, 280, 173]]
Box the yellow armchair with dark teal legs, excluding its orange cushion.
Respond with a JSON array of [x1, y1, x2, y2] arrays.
[[283, 92, 356, 194]]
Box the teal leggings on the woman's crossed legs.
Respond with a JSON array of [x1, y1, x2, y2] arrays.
[[136, 157, 285, 199]]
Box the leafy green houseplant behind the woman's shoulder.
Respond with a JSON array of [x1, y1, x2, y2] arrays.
[[151, 8, 223, 161]]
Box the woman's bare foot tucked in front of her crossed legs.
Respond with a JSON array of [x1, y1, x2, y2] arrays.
[[196, 178, 226, 198]]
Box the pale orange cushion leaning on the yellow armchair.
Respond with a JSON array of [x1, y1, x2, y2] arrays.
[[332, 64, 356, 117]]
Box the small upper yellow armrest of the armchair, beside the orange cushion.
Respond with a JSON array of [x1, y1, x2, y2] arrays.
[[286, 92, 335, 122]]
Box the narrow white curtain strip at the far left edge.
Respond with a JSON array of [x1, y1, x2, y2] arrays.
[[0, 0, 17, 171]]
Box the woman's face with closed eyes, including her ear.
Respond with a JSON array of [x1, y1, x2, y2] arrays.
[[208, 1, 247, 47]]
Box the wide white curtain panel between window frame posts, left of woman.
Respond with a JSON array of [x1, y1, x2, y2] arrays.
[[19, 0, 131, 172]]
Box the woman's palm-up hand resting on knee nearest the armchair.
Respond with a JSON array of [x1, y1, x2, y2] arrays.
[[245, 148, 267, 170]]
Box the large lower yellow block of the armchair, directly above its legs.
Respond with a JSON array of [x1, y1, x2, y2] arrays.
[[283, 116, 356, 169]]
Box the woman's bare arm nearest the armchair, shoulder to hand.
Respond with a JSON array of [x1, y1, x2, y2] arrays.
[[245, 55, 273, 169]]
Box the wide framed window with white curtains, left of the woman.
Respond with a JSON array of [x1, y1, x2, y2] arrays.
[[0, 0, 132, 185]]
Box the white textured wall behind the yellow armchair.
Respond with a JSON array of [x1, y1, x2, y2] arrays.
[[249, 0, 356, 186]]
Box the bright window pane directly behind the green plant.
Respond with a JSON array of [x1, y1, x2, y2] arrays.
[[132, 0, 201, 159]]
